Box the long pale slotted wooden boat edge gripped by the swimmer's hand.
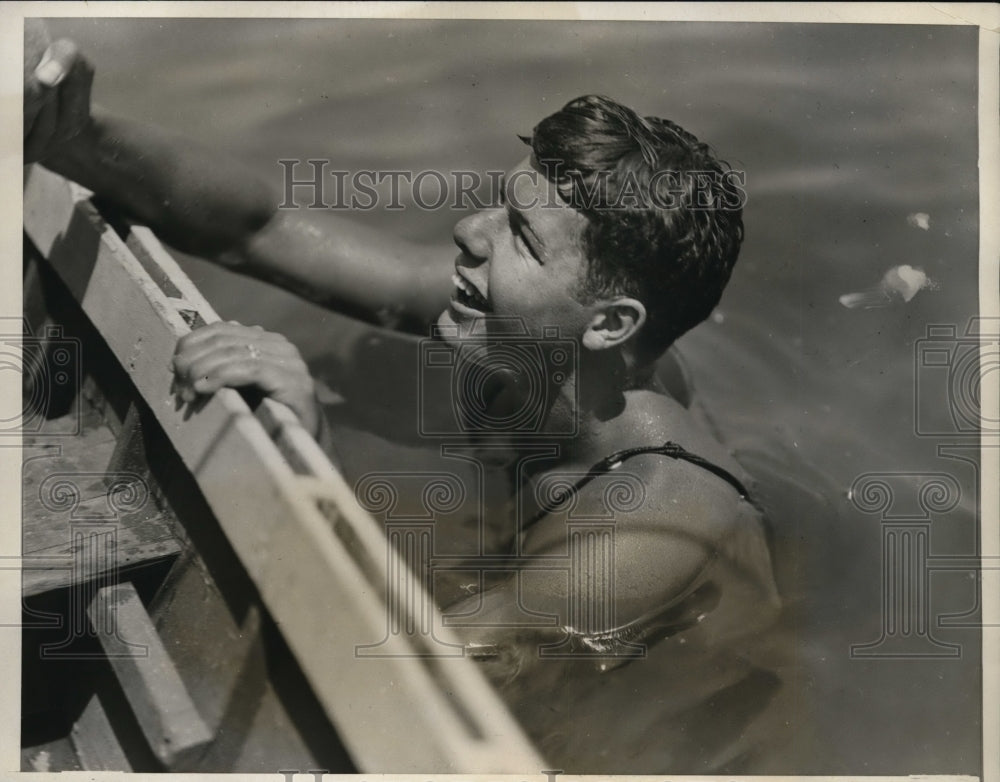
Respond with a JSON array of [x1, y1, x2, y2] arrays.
[[25, 169, 545, 773]]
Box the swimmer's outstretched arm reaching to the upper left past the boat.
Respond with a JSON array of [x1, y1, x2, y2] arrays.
[[25, 41, 450, 324]]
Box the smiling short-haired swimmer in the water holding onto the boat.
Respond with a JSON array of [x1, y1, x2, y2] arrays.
[[25, 33, 777, 736]]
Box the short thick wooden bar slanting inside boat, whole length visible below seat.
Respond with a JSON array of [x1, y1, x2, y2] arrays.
[[87, 583, 212, 770]]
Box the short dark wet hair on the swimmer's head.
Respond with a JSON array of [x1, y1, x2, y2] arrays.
[[523, 95, 745, 359]]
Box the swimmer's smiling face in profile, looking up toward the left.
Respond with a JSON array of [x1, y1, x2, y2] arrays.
[[438, 158, 591, 340]]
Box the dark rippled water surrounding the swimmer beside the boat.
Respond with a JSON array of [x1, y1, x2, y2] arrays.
[[43, 20, 981, 774]]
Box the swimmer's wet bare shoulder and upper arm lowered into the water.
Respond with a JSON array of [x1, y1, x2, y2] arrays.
[[445, 466, 775, 667]]
